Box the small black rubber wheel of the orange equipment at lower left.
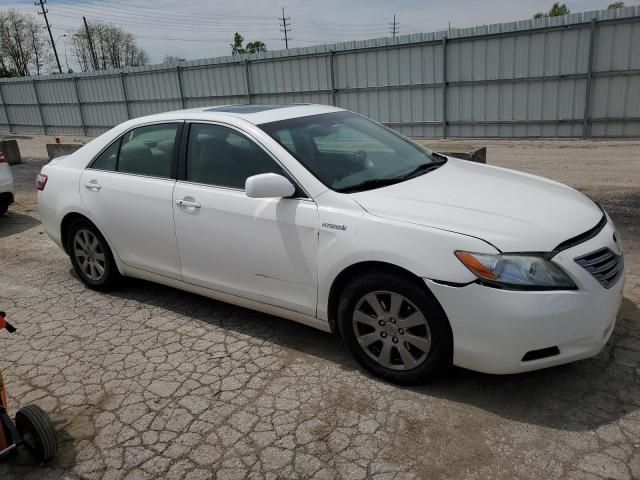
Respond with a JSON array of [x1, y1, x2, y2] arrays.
[[16, 405, 58, 463]]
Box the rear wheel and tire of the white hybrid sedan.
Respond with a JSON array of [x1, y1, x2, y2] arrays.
[[67, 220, 121, 292]]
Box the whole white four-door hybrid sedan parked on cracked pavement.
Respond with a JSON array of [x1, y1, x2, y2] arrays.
[[37, 105, 624, 383]]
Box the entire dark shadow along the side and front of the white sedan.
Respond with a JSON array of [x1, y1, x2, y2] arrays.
[[102, 279, 640, 431]]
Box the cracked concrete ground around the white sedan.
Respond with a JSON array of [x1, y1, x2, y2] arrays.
[[0, 139, 640, 480]]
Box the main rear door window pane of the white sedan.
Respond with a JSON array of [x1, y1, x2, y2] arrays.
[[117, 123, 180, 178]]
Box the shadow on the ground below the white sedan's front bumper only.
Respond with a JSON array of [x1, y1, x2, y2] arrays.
[[411, 298, 640, 431]]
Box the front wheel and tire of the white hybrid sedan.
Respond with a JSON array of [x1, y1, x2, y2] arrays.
[[337, 272, 453, 385]]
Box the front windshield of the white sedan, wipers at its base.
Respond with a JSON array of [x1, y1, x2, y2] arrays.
[[259, 112, 443, 192]]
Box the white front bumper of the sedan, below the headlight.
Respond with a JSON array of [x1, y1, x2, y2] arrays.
[[425, 221, 624, 374]]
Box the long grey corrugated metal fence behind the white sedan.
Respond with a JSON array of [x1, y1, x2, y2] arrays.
[[0, 7, 640, 138]]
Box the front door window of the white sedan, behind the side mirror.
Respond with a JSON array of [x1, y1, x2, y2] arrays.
[[187, 124, 284, 190]]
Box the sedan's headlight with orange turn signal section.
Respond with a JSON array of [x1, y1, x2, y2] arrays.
[[455, 250, 576, 290]]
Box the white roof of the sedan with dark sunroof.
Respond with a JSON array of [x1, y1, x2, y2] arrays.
[[126, 103, 344, 125]]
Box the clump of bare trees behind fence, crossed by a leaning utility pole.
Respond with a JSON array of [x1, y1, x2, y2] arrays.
[[71, 23, 149, 72]]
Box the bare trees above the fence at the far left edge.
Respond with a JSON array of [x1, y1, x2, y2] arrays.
[[0, 10, 52, 77]]
